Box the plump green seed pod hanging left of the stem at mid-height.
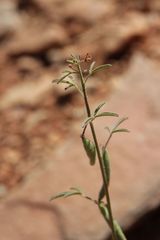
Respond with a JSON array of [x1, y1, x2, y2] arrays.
[[82, 136, 96, 165]]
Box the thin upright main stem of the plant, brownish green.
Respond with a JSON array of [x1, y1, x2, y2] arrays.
[[78, 64, 116, 240]]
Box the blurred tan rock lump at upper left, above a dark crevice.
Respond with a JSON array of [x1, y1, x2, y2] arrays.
[[7, 23, 68, 56]]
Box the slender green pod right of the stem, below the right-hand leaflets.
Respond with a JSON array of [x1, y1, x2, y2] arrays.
[[102, 148, 110, 185]]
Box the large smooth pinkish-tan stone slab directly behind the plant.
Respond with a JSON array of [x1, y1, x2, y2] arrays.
[[0, 54, 160, 240]]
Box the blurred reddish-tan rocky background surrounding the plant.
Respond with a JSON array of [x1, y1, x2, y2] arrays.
[[0, 0, 160, 240]]
